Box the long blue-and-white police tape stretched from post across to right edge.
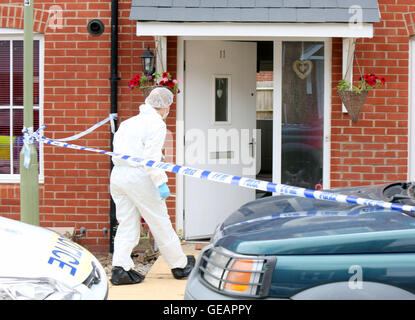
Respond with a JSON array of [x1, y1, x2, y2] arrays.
[[29, 132, 415, 212]]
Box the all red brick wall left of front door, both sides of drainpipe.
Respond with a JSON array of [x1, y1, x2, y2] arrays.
[[0, 0, 180, 252]]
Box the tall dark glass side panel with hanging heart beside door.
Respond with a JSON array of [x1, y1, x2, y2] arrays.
[[281, 41, 324, 189]]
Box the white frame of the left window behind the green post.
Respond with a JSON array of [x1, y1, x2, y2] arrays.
[[0, 28, 45, 184]]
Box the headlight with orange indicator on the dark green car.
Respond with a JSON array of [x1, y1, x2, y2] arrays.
[[199, 247, 276, 297]]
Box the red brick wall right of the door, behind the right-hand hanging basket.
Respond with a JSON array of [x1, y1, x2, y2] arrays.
[[331, 0, 415, 187]]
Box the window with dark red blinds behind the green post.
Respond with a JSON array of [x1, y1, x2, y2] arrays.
[[0, 34, 43, 182]]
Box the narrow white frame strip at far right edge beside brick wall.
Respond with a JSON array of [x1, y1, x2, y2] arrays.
[[408, 37, 415, 181]]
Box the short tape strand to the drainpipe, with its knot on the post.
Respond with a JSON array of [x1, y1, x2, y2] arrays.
[[22, 113, 118, 169]]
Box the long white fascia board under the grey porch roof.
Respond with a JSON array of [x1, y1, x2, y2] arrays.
[[137, 21, 373, 38]]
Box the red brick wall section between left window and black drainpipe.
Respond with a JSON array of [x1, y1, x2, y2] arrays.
[[40, 0, 111, 255]]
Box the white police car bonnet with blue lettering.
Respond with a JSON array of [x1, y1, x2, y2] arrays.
[[0, 217, 94, 287]]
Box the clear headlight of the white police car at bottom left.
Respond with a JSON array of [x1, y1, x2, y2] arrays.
[[0, 277, 81, 300]]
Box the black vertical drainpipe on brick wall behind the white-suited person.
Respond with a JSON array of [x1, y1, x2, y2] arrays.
[[110, 0, 120, 253]]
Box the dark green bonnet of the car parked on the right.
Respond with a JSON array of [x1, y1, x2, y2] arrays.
[[215, 196, 415, 254]]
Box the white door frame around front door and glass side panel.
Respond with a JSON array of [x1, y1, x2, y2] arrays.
[[176, 37, 332, 236]]
